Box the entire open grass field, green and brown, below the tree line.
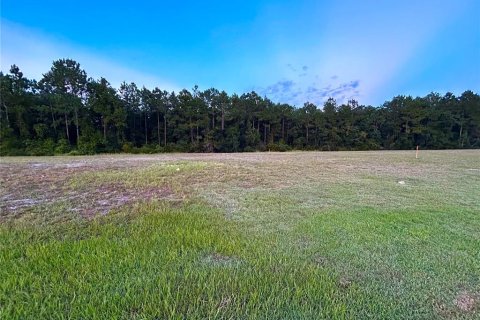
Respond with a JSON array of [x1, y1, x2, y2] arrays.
[[0, 150, 480, 319]]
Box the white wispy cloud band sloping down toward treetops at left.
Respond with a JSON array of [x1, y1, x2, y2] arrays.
[[0, 19, 179, 91]]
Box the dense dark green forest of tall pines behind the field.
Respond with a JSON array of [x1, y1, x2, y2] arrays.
[[0, 59, 480, 155]]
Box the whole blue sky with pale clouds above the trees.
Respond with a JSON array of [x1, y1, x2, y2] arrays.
[[0, 0, 480, 106]]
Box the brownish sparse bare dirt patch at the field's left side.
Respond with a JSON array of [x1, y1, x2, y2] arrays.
[[0, 156, 179, 221]]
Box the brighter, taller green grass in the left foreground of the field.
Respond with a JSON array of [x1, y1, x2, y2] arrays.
[[0, 204, 362, 319]]
